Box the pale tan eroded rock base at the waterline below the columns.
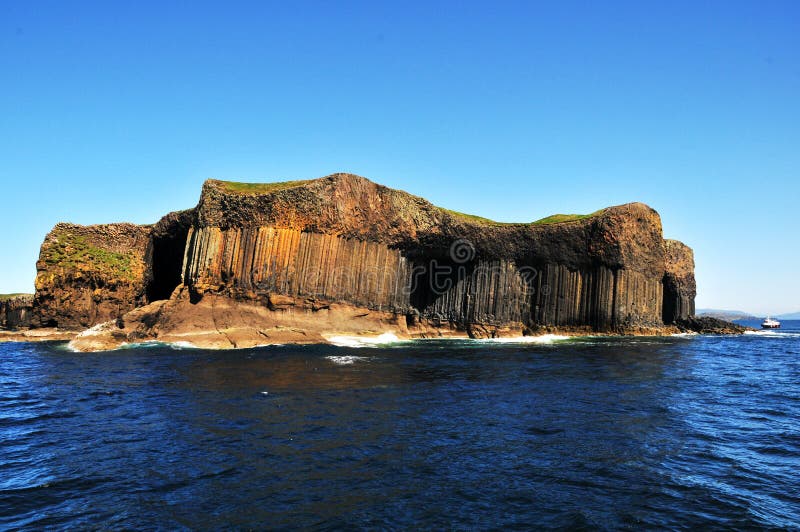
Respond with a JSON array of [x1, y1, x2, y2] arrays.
[[70, 287, 720, 351]]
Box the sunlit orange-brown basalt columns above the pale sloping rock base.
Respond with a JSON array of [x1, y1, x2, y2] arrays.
[[183, 227, 411, 312]]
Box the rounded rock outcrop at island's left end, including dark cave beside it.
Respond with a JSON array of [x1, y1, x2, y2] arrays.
[[33, 210, 194, 330]]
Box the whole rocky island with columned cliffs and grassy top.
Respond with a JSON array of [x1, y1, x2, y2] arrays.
[[3, 173, 748, 351]]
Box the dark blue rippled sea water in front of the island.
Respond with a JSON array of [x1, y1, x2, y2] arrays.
[[0, 322, 800, 529]]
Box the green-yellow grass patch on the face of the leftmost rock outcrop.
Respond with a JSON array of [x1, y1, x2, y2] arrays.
[[42, 233, 136, 280]]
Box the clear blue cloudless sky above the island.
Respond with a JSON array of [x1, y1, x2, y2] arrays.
[[0, 0, 800, 314]]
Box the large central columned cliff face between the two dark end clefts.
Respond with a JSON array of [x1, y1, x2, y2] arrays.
[[184, 174, 676, 331]]
